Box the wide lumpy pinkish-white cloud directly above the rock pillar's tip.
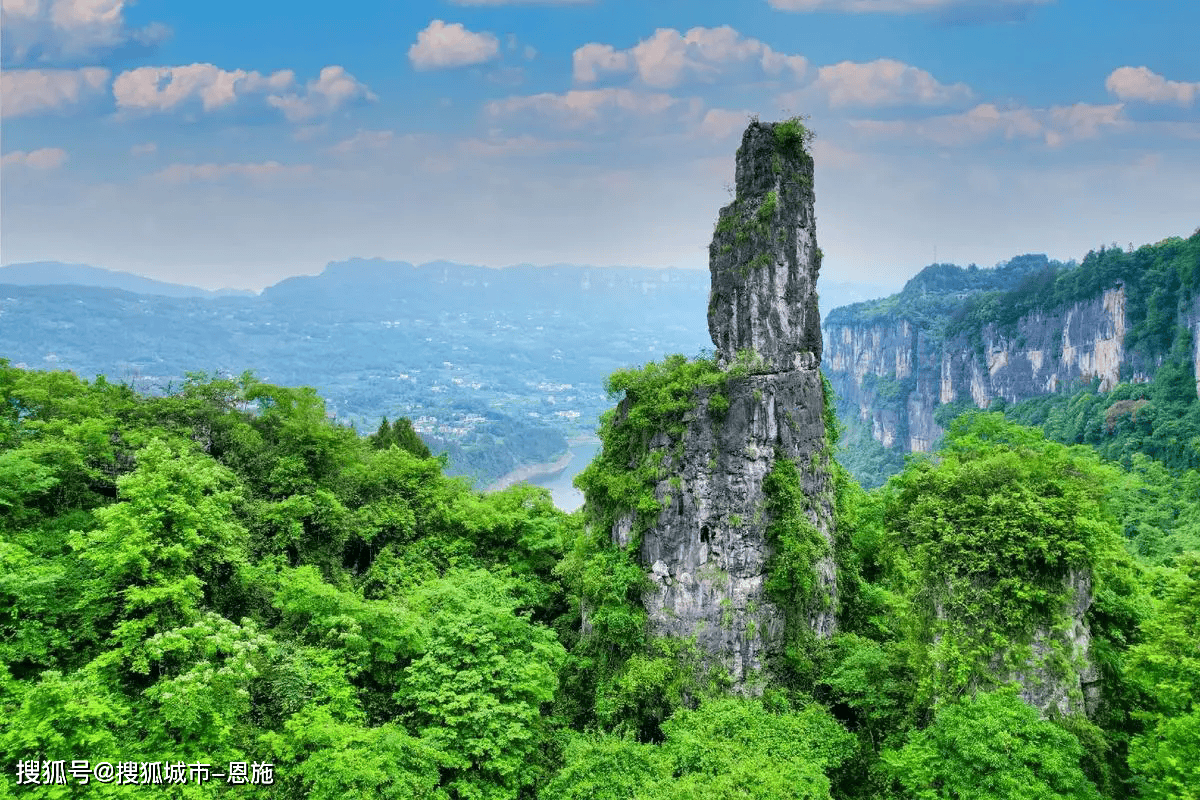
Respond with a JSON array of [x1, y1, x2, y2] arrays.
[[572, 25, 808, 89]]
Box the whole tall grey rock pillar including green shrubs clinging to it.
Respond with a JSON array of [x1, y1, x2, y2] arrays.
[[581, 120, 836, 692]]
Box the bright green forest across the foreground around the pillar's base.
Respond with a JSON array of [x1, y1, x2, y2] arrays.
[[0, 359, 1200, 800]]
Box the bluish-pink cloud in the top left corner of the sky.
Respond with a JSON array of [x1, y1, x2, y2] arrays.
[[0, 0, 170, 64]]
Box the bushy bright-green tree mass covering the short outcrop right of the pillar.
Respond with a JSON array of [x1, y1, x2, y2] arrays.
[[886, 414, 1128, 698]]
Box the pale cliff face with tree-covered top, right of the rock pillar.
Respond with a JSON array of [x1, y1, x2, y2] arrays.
[[824, 234, 1200, 489]]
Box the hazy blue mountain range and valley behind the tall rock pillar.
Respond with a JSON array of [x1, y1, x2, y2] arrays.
[[0, 259, 887, 482]]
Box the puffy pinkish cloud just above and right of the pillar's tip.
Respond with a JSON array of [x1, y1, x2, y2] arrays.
[[814, 59, 971, 108]]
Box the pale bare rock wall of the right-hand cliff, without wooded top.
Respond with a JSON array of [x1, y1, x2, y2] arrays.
[[823, 235, 1200, 470]]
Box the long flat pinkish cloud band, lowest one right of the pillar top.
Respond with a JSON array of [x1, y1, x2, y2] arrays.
[[851, 103, 1127, 146]]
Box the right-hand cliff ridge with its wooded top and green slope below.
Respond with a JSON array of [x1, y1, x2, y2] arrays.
[[824, 230, 1200, 486]]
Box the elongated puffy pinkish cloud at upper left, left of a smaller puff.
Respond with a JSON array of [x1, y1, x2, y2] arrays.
[[113, 64, 295, 112]]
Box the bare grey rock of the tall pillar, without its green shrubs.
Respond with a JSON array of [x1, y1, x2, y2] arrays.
[[628, 121, 836, 692]]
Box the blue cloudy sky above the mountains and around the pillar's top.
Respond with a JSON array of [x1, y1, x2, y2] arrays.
[[0, 0, 1200, 289]]
